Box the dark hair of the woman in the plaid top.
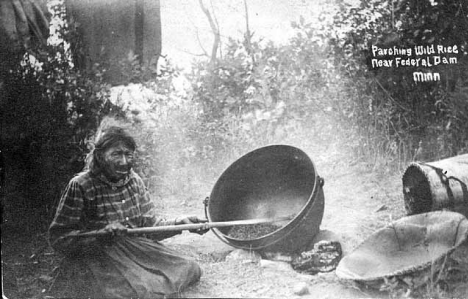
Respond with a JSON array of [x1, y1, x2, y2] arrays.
[[84, 126, 136, 174]]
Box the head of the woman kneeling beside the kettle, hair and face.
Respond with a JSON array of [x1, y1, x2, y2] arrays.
[[89, 126, 136, 181]]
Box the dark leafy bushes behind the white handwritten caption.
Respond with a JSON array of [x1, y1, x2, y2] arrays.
[[327, 0, 468, 163]]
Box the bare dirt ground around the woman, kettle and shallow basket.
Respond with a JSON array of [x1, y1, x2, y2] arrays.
[[2, 163, 468, 298]]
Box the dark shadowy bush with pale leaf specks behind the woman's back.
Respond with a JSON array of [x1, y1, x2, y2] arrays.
[[1, 2, 112, 229]]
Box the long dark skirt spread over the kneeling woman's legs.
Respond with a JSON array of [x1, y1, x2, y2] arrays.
[[51, 236, 201, 299]]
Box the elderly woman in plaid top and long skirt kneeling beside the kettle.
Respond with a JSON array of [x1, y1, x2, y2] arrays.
[[49, 127, 207, 298]]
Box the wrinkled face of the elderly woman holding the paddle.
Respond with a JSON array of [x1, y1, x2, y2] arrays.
[[103, 142, 134, 182]]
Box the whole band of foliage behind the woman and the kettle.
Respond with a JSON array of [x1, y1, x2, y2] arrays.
[[0, 0, 468, 234]]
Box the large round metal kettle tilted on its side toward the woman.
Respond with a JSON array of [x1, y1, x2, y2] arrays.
[[205, 145, 324, 252]]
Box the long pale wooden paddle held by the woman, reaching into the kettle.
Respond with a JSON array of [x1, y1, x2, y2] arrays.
[[67, 216, 292, 238]]
